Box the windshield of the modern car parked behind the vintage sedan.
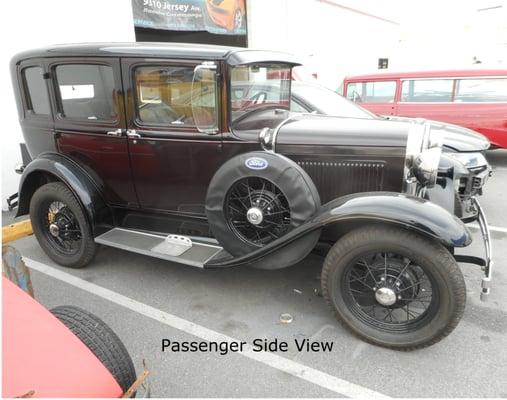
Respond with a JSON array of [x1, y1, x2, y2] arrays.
[[292, 83, 376, 119]]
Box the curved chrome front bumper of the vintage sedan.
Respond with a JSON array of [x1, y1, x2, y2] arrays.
[[454, 197, 493, 301]]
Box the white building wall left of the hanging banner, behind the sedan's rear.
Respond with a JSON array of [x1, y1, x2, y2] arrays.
[[0, 0, 135, 209]]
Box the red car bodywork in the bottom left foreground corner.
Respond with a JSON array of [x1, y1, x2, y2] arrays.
[[2, 278, 122, 397]]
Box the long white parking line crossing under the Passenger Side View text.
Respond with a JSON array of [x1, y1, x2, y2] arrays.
[[23, 257, 390, 399]]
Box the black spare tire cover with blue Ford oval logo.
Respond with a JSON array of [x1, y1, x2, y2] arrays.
[[206, 151, 320, 256]]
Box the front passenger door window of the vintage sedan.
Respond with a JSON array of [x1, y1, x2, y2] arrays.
[[135, 65, 205, 126]]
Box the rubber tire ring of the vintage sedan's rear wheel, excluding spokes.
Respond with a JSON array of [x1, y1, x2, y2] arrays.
[[30, 182, 97, 268]]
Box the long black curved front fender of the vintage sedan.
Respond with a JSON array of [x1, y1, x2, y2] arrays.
[[205, 192, 472, 268]]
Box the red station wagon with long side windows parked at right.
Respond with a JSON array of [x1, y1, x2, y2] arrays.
[[343, 69, 507, 148]]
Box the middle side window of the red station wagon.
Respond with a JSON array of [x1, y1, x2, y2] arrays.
[[401, 79, 454, 103]]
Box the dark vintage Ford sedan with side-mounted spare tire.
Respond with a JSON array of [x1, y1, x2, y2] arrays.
[[12, 44, 492, 349]]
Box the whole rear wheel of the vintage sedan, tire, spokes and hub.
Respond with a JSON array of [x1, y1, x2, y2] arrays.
[[30, 182, 96, 268]]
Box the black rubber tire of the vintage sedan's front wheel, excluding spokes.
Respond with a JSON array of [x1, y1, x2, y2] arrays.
[[321, 226, 466, 351]]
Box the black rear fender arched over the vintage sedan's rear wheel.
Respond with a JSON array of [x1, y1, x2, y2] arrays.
[[16, 153, 113, 233]]
